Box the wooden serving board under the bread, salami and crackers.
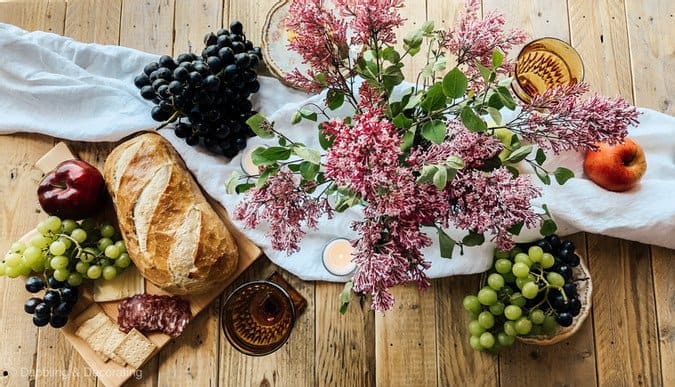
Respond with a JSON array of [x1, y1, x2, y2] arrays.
[[21, 142, 262, 387]]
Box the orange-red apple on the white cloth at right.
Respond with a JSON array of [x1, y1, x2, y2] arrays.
[[584, 137, 647, 192]]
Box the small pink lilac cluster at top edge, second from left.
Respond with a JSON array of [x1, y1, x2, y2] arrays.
[[337, 0, 405, 45]]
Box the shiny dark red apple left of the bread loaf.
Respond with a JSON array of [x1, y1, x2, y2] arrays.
[[38, 160, 105, 220]]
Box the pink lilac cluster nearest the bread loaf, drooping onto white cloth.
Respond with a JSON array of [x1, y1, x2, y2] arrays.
[[234, 169, 332, 254]]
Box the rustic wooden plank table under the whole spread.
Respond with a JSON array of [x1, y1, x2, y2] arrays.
[[0, 0, 675, 387]]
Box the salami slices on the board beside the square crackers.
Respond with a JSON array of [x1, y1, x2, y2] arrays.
[[117, 294, 192, 337]]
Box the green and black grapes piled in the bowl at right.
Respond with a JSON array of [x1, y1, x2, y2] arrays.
[[463, 235, 581, 353]]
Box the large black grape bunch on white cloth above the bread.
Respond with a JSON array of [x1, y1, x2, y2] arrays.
[[134, 21, 262, 158]]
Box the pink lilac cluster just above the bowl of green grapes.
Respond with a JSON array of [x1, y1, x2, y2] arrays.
[[449, 167, 541, 250]]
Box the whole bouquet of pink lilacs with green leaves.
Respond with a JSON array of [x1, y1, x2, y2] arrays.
[[228, 0, 637, 311]]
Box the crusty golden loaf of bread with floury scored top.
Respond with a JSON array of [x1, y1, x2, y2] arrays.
[[104, 133, 239, 294]]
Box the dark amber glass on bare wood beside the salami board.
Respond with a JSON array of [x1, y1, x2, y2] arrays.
[[222, 272, 307, 356]]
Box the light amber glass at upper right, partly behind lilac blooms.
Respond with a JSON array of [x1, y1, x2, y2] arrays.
[[511, 38, 584, 103]]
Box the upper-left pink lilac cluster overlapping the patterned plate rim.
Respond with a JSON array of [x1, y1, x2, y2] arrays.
[[285, 0, 349, 91]]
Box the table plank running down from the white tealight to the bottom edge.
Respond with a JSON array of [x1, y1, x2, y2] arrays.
[[315, 283, 375, 386]]
